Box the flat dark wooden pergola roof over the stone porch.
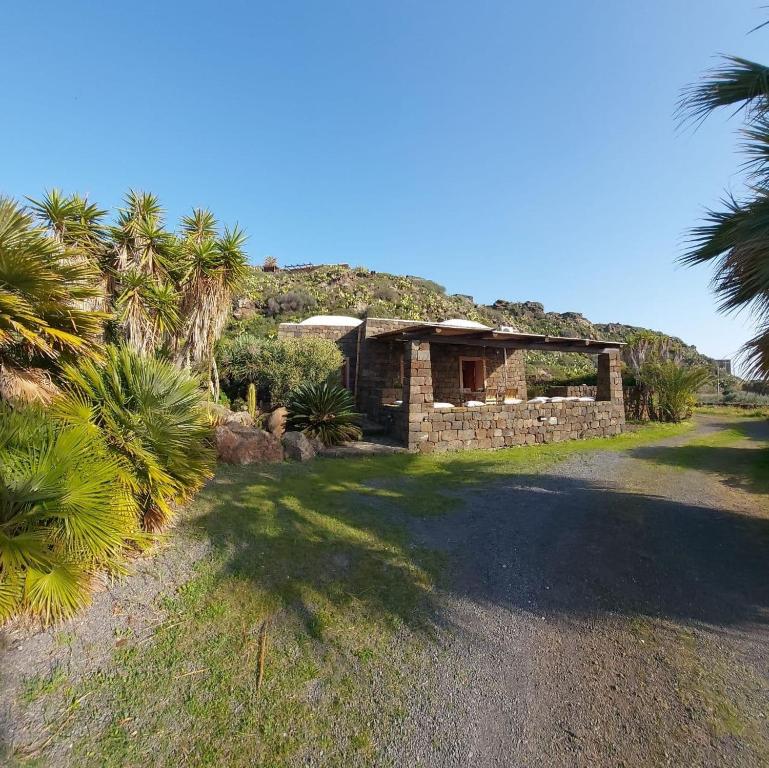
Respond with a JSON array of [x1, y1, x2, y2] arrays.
[[370, 323, 624, 355]]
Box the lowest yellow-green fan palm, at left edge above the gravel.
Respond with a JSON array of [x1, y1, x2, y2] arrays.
[[0, 405, 138, 622]]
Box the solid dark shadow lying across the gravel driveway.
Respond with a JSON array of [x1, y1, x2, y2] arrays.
[[420, 475, 769, 626]]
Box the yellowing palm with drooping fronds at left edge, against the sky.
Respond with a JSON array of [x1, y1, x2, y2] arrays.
[[0, 198, 106, 400]]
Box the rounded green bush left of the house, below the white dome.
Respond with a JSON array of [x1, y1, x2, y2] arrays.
[[220, 336, 344, 405]]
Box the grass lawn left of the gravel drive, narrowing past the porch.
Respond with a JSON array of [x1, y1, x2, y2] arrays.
[[16, 425, 690, 766]]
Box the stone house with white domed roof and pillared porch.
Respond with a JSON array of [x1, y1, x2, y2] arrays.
[[278, 316, 625, 453]]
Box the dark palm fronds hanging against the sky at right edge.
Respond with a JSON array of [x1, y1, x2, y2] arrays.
[[680, 56, 769, 378]]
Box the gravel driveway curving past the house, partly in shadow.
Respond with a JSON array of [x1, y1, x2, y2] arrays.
[[395, 418, 769, 768]]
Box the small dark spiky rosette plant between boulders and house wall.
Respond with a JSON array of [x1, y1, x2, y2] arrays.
[[287, 382, 362, 445]]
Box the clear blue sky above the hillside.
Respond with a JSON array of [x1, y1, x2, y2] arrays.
[[0, 0, 769, 368]]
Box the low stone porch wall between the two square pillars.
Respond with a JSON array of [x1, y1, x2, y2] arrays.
[[408, 401, 625, 453]]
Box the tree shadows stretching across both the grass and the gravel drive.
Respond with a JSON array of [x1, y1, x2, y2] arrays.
[[192, 449, 769, 635]]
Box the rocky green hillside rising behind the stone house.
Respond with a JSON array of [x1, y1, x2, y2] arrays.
[[228, 265, 711, 378]]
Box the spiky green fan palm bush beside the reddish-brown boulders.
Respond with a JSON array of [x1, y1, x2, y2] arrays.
[[56, 345, 214, 531]]
